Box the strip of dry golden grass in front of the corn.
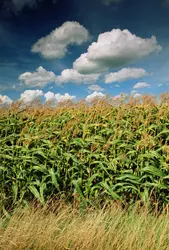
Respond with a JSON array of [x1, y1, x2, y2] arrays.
[[0, 202, 169, 250]]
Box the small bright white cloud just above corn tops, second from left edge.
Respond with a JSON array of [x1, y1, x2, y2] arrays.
[[19, 89, 43, 104]]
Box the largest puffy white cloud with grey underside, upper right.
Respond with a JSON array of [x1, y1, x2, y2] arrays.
[[73, 29, 162, 74]]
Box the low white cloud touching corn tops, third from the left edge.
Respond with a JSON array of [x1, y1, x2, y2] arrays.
[[44, 91, 76, 103]]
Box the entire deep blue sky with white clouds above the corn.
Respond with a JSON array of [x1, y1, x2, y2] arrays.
[[0, 0, 169, 104]]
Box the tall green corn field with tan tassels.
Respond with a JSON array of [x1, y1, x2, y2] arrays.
[[0, 96, 169, 212]]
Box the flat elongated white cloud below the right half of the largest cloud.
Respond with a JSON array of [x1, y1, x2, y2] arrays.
[[105, 68, 150, 83]]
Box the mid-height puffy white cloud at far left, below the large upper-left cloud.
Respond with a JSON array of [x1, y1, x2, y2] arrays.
[[19, 66, 56, 88]]
